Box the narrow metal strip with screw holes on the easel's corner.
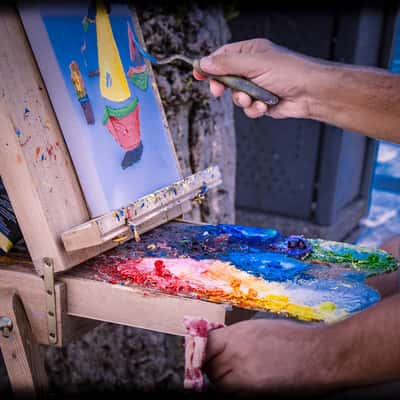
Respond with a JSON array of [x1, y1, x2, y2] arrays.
[[43, 257, 58, 344]]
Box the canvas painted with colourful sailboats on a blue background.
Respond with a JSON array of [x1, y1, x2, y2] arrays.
[[19, 1, 181, 217]]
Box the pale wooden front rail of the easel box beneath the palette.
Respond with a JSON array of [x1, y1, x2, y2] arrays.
[[58, 267, 228, 336]]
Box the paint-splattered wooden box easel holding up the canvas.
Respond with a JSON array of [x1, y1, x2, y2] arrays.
[[0, 8, 252, 396]]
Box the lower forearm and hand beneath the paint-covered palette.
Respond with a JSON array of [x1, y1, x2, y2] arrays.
[[206, 295, 400, 394]]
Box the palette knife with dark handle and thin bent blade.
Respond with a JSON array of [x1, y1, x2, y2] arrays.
[[155, 54, 279, 106]]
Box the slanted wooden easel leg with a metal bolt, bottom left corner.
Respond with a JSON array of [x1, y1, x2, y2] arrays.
[[0, 289, 47, 398]]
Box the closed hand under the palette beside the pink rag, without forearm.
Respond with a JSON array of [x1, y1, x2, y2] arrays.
[[205, 319, 331, 394]]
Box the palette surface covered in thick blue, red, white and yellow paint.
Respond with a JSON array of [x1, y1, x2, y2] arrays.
[[80, 223, 398, 322]]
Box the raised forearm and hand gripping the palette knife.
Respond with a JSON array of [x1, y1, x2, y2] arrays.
[[194, 39, 400, 142]]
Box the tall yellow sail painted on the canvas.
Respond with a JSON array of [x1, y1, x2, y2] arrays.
[[96, 1, 131, 102]]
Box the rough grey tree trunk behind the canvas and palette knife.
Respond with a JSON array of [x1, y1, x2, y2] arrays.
[[139, 5, 236, 223]]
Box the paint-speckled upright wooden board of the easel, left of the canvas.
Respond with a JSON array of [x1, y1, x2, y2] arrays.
[[0, 7, 116, 274]]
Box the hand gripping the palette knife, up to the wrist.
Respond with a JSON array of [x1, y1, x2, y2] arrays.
[[193, 39, 322, 118]]
